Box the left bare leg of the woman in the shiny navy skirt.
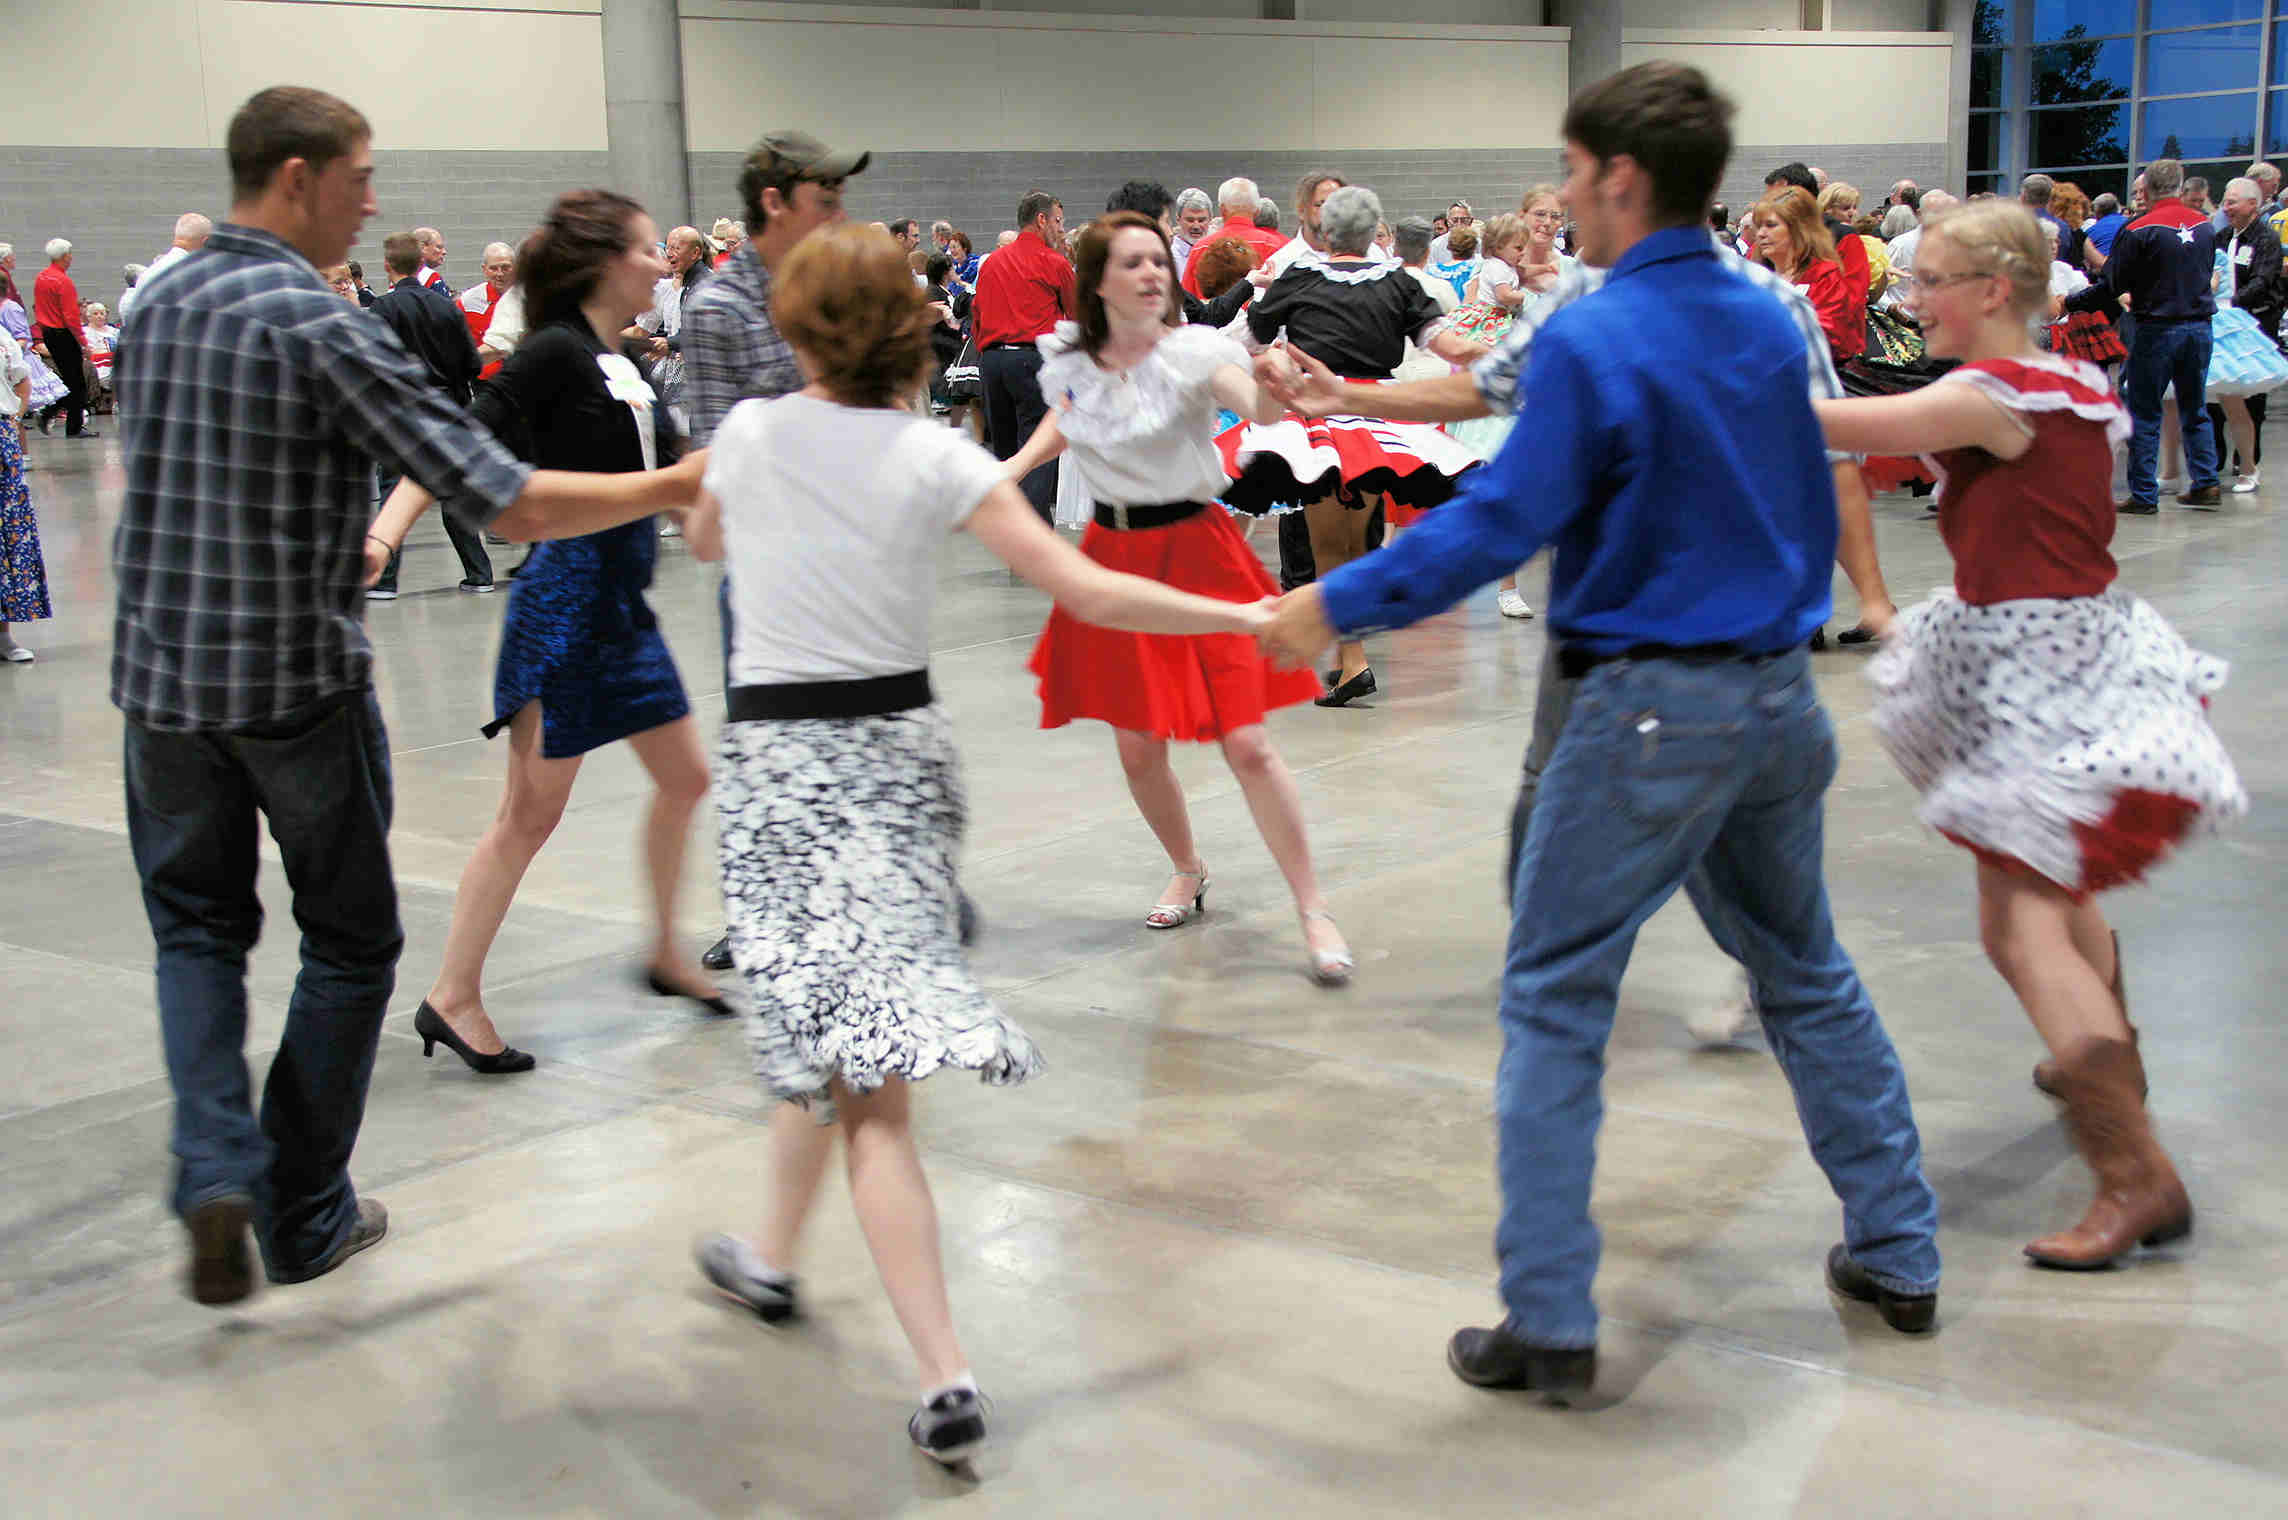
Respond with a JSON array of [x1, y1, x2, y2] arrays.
[[428, 703, 579, 1055]]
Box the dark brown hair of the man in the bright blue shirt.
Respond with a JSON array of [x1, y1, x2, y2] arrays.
[[1563, 62, 1720, 224]]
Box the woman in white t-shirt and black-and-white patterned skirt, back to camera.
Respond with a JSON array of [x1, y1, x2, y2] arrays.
[[684, 224, 1265, 1463]]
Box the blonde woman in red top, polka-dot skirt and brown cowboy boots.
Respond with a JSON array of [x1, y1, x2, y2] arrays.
[[1819, 201, 2247, 1268]]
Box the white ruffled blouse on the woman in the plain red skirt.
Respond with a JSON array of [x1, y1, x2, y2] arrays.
[[1039, 323, 1249, 506]]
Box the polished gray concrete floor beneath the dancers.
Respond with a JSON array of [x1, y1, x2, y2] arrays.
[[0, 440, 2288, 1515]]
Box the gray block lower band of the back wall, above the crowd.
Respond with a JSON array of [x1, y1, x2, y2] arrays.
[[0, 142, 1947, 318]]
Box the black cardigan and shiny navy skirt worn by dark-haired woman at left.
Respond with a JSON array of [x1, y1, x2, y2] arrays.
[[459, 316, 691, 760]]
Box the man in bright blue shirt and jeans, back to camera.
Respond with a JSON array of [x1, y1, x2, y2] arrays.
[[1268, 64, 1938, 1401]]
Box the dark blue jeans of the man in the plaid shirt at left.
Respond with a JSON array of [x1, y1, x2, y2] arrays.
[[126, 691, 405, 1273]]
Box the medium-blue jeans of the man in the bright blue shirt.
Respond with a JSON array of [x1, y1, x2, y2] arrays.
[[1494, 650, 1938, 1346]]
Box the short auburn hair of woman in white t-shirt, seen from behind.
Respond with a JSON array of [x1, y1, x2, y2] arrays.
[[771, 222, 931, 407]]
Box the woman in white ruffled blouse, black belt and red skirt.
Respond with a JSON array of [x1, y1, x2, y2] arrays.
[[1007, 211, 1352, 984]]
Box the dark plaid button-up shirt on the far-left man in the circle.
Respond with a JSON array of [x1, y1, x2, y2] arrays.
[[112, 224, 531, 730]]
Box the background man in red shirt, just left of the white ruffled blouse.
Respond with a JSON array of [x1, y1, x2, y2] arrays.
[[970, 190, 1075, 522]]
